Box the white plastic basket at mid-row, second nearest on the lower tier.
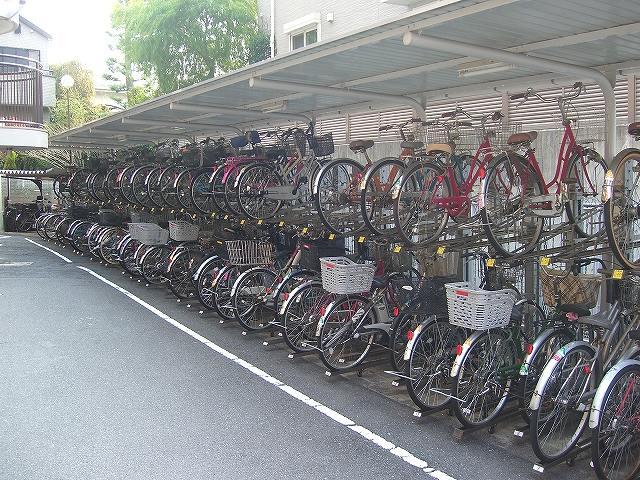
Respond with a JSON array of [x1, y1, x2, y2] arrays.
[[320, 257, 376, 295]]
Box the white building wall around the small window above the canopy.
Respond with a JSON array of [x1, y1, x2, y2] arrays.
[[258, 0, 408, 54]]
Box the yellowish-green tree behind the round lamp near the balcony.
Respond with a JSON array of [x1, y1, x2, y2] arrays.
[[47, 60, 109, 134]]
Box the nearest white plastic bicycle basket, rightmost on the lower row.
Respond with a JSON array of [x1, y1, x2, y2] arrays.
[[445, 282, 516, 330]]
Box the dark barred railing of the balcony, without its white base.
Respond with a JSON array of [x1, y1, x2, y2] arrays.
[[0, 54, 44, 129]]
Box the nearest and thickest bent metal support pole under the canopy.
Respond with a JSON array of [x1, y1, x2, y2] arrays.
[[402, 32, 617, 162]]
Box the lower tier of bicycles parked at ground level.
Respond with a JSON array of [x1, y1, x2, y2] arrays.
[[37, 214, 640, 479]]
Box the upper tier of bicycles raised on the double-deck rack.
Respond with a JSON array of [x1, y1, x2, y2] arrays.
[[50, 83, 640, 269]]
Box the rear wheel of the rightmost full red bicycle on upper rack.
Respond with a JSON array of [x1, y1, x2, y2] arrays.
[[481, 153, 544, 257]]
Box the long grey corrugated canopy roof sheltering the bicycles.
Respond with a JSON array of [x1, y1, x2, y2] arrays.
[[51, 0, 640, 153]]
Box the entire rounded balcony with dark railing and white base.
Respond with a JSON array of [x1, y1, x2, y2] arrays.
[[0, 54, 49, 150]]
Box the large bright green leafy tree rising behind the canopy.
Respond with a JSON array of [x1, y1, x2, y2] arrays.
[[112, 0, 268, 94]]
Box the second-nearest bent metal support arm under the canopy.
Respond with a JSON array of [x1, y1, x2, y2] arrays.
[[249, 77, 427, 120]]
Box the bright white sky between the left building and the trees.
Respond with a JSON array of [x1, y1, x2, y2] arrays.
[[21, 0, 115, 87]]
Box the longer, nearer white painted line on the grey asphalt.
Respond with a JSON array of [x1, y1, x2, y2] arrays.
[[77, 265, 456, 480]]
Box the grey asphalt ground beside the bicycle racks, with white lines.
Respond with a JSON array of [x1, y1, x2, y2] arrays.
[[0, 234, 595, 480]]
